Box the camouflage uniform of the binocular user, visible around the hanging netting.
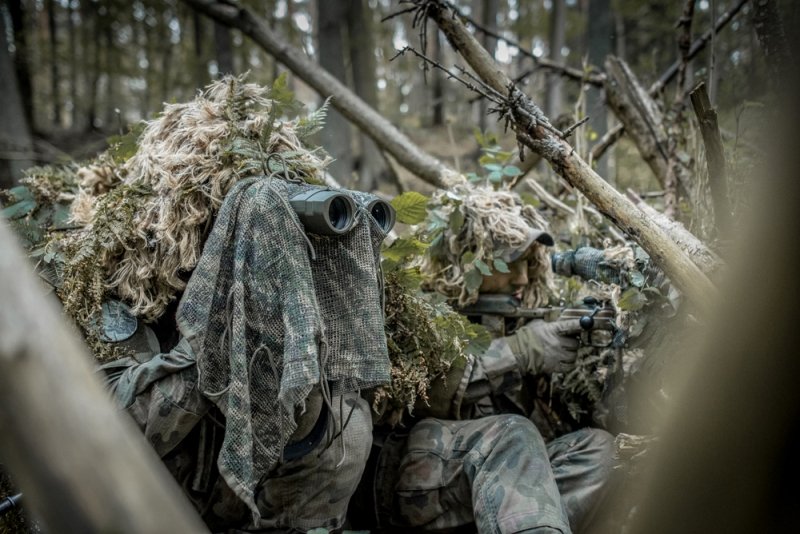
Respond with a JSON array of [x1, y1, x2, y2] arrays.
[[100, 325, 372, 532]]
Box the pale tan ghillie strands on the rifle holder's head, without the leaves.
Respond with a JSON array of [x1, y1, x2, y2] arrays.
[[420, 185, 552, 307]]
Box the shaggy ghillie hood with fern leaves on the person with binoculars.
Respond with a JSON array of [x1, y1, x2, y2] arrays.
[[4, 77, 330, 358]]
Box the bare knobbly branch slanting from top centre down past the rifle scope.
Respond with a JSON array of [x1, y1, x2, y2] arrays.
[[427, 3, 716, 308]]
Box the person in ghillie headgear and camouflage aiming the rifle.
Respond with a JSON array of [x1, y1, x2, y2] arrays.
[[351, 187, 614, 534]]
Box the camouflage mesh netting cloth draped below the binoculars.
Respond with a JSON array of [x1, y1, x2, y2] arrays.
[[177, 178, 389, 521]]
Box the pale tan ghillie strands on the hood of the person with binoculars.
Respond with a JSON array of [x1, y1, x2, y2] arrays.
[[61, 73, 329, 321]]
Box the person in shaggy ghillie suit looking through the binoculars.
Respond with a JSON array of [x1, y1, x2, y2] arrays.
[[4, 78, 390, 532]]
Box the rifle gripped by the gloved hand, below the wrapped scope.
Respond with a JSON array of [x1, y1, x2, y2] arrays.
[[458, 294, 616, 347]]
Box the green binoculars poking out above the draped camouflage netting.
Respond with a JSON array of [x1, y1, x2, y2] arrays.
[[289, 187, 395, 236]]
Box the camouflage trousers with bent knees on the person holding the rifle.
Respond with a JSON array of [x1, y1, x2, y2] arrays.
[[391, 414, 613, 534]]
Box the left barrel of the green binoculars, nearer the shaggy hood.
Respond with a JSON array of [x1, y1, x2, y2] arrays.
[[289, 189, 356, 235]]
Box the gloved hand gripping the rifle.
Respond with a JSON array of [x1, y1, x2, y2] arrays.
[[504, 319, 581, 374]]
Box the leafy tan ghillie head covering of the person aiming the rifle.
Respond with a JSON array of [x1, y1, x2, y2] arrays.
[[420, 184, 553, 307]]
